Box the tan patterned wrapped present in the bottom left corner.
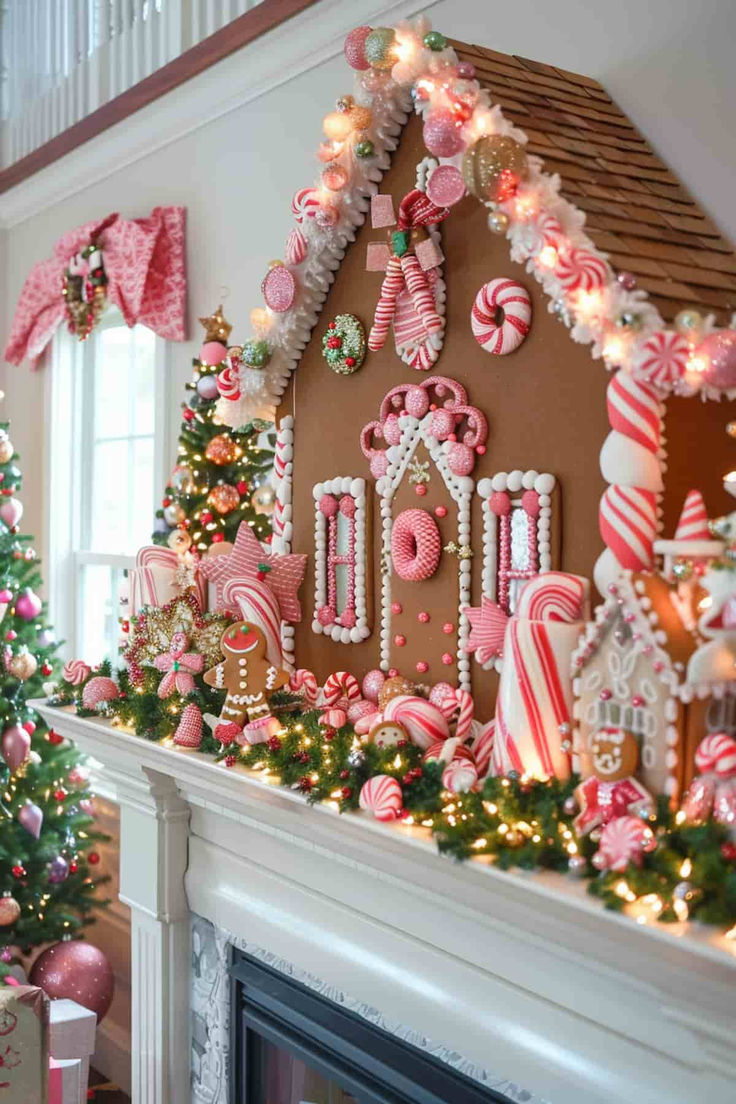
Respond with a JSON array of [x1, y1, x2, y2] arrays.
[[0, 985, 49, 1104]]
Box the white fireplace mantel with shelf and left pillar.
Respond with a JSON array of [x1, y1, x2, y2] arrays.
[[33, 702, 736, 1104]]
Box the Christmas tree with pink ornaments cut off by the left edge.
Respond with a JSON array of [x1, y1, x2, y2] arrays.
[[0, 423, 103, 979]]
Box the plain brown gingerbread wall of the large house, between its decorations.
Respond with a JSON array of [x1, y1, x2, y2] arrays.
[[279, 109, 736, 718]]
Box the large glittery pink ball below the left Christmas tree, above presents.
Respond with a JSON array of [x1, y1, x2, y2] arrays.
[[29, 940, 115, 1023]]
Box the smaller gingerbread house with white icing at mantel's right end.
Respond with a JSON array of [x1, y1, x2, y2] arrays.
[[573, 491, 736, 799]]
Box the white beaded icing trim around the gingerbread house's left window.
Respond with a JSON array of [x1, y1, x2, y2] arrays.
[[312, 476, 371, 644]]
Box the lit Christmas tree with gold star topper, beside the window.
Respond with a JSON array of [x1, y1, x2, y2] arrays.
[[153, 307, 275, 553]]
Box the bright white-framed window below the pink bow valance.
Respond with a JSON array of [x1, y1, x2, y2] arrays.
[[46, 308, 166, 662]]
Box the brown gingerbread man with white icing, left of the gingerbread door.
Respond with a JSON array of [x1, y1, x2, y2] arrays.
[[203, 622, 289, 728]]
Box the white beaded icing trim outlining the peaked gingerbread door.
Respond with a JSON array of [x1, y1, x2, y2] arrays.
[[375, 411, 474, 691]]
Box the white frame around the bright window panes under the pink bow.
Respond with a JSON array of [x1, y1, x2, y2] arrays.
[[43, 311, 170, 660]]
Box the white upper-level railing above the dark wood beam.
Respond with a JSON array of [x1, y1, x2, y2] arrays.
[[0, 0, 260, 168]]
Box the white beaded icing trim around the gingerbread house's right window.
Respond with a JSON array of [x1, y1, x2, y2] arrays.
[[476, 468, 557, 671]]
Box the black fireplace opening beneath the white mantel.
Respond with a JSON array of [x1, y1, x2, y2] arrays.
[[230, 951, 512, 1104]]
